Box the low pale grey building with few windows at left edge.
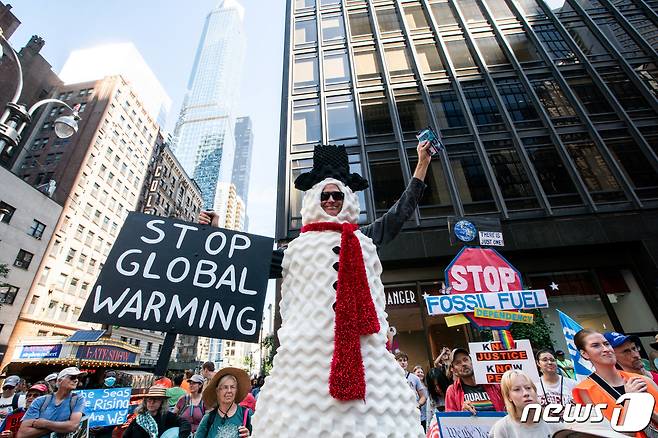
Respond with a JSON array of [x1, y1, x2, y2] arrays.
[[0, 168, 62, 364]]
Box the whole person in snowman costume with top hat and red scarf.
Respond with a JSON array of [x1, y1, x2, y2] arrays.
[[199, 142, 431, 438]]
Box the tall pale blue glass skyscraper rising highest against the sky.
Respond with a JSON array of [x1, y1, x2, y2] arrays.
[[172, 0, 245, 208]]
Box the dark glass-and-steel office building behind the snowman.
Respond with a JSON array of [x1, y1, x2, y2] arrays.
[[277, 0, 658, 370]]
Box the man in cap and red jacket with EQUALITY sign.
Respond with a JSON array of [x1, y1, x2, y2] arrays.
[[446, 348, 505, 415]]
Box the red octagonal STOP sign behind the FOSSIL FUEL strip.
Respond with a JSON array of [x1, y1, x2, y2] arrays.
[[445, 246, 523, 329]]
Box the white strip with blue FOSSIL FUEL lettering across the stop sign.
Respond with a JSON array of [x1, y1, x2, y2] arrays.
[[425, 289, 548, 314]]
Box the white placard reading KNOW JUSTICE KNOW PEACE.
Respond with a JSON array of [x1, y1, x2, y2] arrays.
[[468, 339, 539, 384]]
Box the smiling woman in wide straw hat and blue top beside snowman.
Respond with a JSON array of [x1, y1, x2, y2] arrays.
[[195, 368, 251, 438]]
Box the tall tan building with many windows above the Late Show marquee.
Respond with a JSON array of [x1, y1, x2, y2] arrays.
[[0, 76, 162, 370]]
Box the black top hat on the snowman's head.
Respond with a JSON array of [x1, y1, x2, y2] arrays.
[[295, 144, 368, 192]]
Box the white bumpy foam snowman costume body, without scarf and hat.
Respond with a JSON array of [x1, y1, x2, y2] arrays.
[[252, 163, 424, 438]]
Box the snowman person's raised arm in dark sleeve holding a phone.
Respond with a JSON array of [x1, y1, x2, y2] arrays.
[[361, 142, 432, 247]]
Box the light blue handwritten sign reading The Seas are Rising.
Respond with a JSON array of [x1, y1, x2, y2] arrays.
[[76, 388, 132, 427]]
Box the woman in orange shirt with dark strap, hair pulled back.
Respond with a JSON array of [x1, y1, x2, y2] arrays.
[[573, 329, 658, 438]]
